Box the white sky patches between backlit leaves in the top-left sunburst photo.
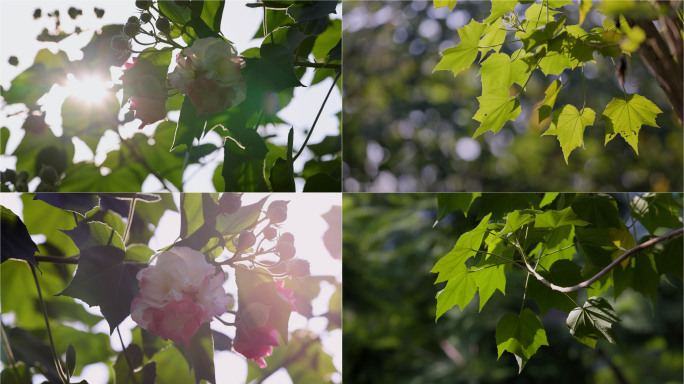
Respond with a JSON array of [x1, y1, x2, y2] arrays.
[[0, 0, 342, 192]]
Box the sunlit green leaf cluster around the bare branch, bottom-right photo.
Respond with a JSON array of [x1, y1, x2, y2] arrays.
[[430, 194, 682, 370]]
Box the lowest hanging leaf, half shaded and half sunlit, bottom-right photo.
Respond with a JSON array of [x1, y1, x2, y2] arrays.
[[496, 308, 549, 372]]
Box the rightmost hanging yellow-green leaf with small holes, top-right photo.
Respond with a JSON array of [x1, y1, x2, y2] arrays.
[[601, 94, 663, 155]]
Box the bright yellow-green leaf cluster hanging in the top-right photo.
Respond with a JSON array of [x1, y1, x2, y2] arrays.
[[434, 1, 662, 163]]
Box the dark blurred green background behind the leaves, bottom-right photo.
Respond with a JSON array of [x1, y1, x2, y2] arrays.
[[343, 194, 684, 384]]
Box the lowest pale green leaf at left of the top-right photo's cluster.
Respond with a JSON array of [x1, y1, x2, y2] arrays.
[[473, 87, 521, 138]]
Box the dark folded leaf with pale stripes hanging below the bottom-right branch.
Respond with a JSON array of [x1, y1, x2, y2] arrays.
[[566, 296, 620, 348]]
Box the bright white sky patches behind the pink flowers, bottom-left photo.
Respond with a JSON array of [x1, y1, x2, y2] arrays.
[[0, 193, 342, 384]]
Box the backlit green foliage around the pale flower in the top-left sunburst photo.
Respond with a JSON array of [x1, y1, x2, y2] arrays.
[[0, 1, 341, 192]]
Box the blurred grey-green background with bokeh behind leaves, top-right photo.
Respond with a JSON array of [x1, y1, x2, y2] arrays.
[[343, 0, 684, 192]]
